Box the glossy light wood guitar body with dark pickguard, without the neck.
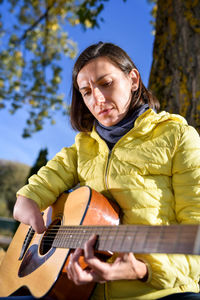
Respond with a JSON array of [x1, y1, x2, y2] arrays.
[[0, 186, 119, 300]]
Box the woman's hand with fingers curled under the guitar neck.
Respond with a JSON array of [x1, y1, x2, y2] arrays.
[[67, 236, 148, 285]]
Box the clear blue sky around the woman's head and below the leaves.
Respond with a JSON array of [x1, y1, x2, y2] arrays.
[[0, 0, 154, 165]]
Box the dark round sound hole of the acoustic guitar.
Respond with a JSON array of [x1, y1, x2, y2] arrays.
[[39, 219, 61, 255]]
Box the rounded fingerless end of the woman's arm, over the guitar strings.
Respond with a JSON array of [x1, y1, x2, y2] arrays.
[[13, 196, 46, 233]]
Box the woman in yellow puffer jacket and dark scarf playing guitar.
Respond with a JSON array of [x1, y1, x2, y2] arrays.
[[14, 42, 200, 300]]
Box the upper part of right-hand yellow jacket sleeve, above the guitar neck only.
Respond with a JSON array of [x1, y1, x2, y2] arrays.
[[172, 126, 200, 224]]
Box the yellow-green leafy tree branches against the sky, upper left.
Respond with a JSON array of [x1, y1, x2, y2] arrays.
[[0, 0, 112, 137]]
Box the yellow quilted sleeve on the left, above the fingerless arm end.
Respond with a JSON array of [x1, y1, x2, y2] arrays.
[[17, 145, 78, 209]]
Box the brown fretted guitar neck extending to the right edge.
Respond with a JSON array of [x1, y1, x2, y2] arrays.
[[52, 225, 200, 254]]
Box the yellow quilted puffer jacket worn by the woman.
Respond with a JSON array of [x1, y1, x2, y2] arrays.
[[18, 109, 200, 300]]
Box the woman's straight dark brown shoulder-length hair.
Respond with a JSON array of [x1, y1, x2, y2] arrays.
[[70, 42, 160, 131]]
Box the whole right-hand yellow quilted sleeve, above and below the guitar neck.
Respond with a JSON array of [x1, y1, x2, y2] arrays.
[[140, 125, 200, 292]]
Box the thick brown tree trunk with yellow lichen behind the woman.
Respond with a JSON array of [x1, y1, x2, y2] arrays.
[[149, 0, 200, 132]]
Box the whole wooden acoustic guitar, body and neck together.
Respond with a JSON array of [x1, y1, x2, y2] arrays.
[[0, 186, 200, 300]]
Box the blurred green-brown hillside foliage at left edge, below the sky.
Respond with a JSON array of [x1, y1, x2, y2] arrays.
[[0, 160, 30, 217]]
